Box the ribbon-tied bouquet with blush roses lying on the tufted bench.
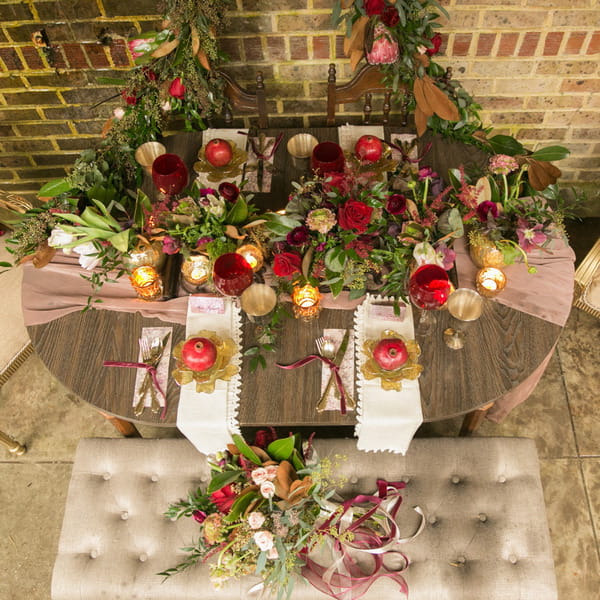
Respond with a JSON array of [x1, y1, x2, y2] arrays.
[[159, 430, 418, 599]]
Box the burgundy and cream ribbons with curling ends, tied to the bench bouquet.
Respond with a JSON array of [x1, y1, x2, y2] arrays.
[[301, 479, 425, 600]]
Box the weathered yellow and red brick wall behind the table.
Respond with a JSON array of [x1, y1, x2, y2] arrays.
[[0, 0, 600, 205]]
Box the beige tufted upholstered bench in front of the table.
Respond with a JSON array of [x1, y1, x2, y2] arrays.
[[52, 438, 557, 600]]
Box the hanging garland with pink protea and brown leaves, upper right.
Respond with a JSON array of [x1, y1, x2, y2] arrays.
[[332, 0, 482, 143]]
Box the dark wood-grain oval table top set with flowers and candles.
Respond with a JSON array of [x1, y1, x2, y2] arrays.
[[28, 128, 561, 435]]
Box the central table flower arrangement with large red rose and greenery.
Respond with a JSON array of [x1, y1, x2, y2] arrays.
[[265, 151, 463, 298]]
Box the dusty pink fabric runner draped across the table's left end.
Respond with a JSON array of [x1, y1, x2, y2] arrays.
[[21, 251, 188, 325]]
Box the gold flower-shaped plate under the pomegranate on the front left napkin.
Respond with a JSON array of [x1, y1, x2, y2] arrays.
[[171, 330, 240, 394]]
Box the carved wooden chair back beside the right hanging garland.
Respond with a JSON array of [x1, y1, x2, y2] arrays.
[[327, 63, 408, 126]]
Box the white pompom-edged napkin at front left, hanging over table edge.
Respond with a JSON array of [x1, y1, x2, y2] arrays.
[[177, 296, 242, 454]]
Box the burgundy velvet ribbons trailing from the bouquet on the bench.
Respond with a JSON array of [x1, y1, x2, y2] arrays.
[[300, 479, 408, 600]]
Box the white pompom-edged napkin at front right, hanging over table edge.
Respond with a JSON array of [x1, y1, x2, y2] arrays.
[[354, 294, 423, 454]]
